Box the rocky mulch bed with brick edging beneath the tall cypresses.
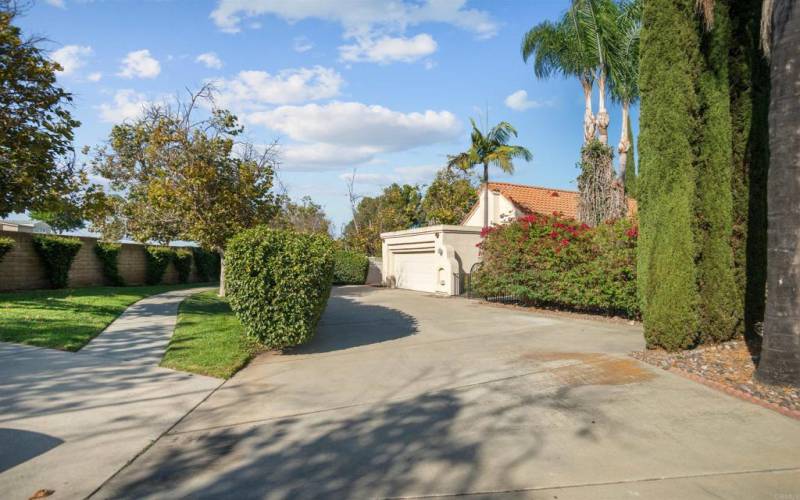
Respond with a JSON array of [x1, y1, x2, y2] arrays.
[[631, 340, 800, 418]]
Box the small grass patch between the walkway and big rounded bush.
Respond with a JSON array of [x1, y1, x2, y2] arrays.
[[161, 292, 259, 378]]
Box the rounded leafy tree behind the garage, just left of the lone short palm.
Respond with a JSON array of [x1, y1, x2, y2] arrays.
[[422, 167, 478, 224]]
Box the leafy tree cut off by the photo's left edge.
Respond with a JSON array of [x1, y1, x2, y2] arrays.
[[0, 0, 80, 217]]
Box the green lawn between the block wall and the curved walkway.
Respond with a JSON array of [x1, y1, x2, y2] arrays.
[[0, 283, 214, 351]]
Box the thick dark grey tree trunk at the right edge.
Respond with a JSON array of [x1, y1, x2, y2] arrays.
[[756, 0, 800, 386]]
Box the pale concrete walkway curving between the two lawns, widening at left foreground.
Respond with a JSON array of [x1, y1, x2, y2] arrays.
[[0, 289, 222, 499]]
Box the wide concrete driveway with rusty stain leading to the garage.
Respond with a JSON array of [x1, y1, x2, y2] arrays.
[[96, 287, 800, 499]]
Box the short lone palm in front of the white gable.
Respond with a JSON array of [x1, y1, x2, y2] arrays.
[[447, 118, 533, 228]]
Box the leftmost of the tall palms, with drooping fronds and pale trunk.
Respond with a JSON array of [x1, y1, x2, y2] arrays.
[[522, 14, 596, 144]]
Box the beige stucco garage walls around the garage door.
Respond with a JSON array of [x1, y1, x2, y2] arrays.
[[381, 225, 481, 295]]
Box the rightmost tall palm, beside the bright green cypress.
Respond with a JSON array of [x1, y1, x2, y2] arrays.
[[610, 0, 642, 190]]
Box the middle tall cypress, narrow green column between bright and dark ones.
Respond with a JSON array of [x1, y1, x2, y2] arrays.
[[693, 0, 738, 342]]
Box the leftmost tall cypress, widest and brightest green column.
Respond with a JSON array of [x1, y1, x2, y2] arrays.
[[638, 0, 699, 350]]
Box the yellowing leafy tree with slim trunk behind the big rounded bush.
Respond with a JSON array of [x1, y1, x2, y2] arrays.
[[93, 87, 279, 295]]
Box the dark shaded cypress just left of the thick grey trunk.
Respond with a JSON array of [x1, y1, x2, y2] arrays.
[[729, 0, 769, 337]]
